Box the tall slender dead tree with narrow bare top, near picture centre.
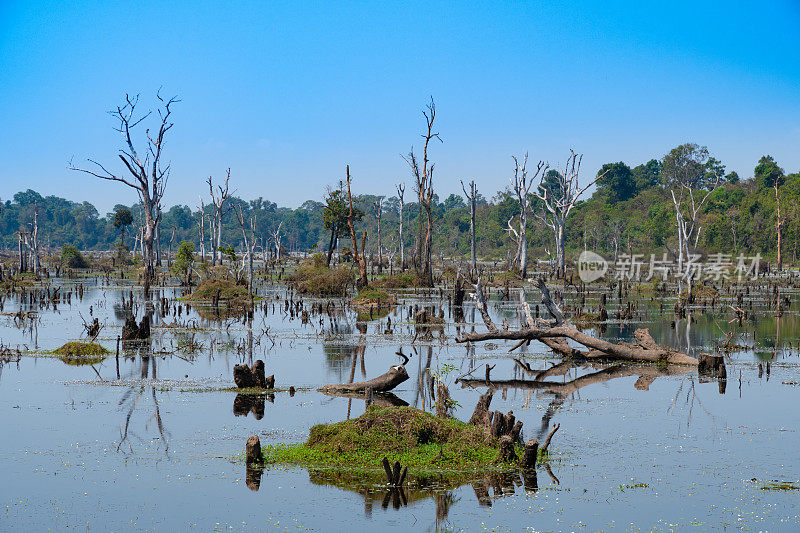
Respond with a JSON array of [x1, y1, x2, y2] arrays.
[[403, 98, 442, 287]]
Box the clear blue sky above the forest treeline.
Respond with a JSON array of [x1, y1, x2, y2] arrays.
[[0, 0, 800, 214]]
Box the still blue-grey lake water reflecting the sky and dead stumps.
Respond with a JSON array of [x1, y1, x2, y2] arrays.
[[0, 280, 800, 531]]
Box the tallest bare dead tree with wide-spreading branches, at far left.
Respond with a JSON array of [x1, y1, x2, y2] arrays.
[[70, 93, 180, 293]]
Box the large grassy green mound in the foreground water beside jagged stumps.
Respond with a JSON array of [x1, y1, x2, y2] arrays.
[[264, 405, 522, 473]]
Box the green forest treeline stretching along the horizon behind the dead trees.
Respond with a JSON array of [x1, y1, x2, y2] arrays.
[[0, 143, 800, 262]]
